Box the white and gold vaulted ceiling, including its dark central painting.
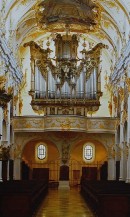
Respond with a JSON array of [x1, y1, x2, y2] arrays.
[[2, 0, 130, 73]]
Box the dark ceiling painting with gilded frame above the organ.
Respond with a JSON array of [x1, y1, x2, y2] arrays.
[[36, 0, 101, 31]]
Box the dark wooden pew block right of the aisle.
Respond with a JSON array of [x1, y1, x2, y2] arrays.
[[81, 179, 130, 217]]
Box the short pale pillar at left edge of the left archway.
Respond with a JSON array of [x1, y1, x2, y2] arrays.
[[14, 157, 21, 180]]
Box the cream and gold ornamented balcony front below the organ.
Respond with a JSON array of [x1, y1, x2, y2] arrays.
[[12, 115, 117, 134]]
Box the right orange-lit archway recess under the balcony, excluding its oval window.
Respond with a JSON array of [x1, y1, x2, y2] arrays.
[[69, 139, 107, 186]]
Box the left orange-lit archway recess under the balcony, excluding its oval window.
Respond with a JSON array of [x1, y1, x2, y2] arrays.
[[21, 140, 59, 181]]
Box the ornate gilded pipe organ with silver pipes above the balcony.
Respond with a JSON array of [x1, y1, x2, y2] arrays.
[[24, 34, 106, 115]]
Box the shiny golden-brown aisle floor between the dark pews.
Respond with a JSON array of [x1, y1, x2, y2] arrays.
[[33, 188, 94, 217]]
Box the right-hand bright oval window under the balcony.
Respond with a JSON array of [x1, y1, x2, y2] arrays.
[[83, 143, 95, 162]]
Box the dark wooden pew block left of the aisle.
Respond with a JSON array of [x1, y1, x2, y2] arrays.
[[0, 180, 48, 217]]
